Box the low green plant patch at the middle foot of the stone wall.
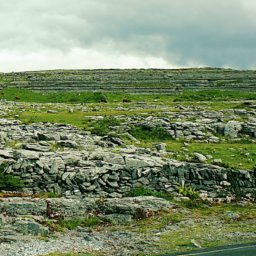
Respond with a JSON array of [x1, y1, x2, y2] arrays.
[[125, 187, 173, 200]]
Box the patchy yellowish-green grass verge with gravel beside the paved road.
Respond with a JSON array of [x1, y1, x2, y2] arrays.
[[120, 203, 256, 255]]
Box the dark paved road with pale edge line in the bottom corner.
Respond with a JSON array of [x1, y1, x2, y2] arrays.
[[163, 243, 256, 256]]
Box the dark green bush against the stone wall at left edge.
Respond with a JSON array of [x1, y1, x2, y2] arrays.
[[0, 165, 24, 191]]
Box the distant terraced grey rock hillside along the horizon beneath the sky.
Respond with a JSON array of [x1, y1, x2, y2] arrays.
[[0, 68, 256, 93]]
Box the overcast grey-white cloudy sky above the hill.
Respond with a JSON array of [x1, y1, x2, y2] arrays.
[[0, 0, 256, 72]]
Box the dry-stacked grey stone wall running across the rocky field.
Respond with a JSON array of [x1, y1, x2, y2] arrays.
[[0, 149, 256, 197]]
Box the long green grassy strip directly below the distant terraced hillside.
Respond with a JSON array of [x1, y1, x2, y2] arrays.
[[0, 88, 256, 103]]
